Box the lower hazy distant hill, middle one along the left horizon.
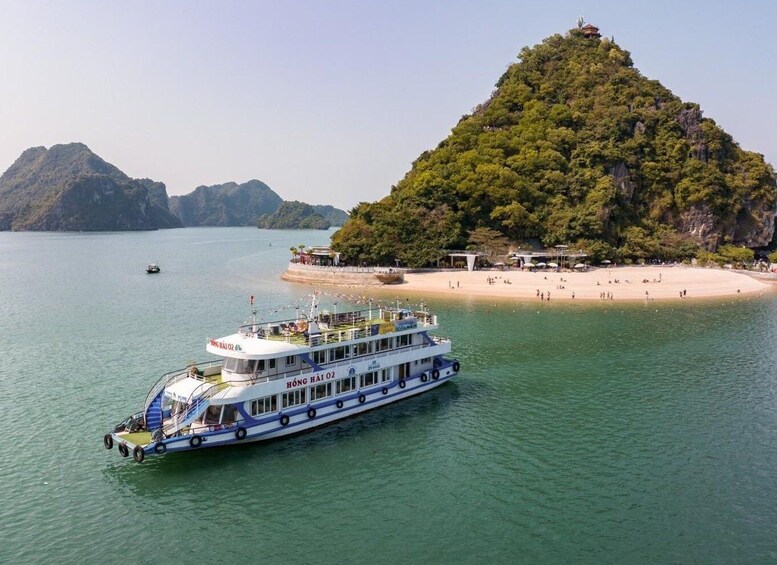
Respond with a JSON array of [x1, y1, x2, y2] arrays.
[[170, 180, 283, 226]]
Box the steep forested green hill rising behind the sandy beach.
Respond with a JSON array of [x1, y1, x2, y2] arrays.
[[332, 24, 777, 266]]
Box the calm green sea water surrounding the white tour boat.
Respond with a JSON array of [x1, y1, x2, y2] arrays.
[[0, 228, 777, 564]]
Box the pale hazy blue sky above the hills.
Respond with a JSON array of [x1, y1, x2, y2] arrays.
[[0, 0, 777, 209]]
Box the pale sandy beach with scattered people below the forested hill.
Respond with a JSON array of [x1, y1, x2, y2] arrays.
[[397, 265, 776, 302]]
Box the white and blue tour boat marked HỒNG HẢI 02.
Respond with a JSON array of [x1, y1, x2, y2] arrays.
[[103, 297, 459, 462]]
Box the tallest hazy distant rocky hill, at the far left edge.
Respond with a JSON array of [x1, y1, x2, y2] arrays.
[[0, 143, 181, 231]]
